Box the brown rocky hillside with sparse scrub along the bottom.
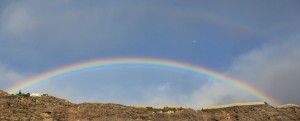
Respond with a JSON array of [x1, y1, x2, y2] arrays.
[[0, 91, 300, 121]]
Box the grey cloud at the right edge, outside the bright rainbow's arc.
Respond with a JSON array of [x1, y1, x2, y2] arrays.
[[229, 36, 300, 104]]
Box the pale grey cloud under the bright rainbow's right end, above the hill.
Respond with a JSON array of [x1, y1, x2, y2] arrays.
[[188, 80, 259, 108]]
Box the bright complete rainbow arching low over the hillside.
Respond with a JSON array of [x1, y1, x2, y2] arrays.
[[8, 58, 280, 105]]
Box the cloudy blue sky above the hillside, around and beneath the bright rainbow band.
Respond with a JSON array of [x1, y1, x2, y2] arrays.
[[0, 0, 300, 108]]
